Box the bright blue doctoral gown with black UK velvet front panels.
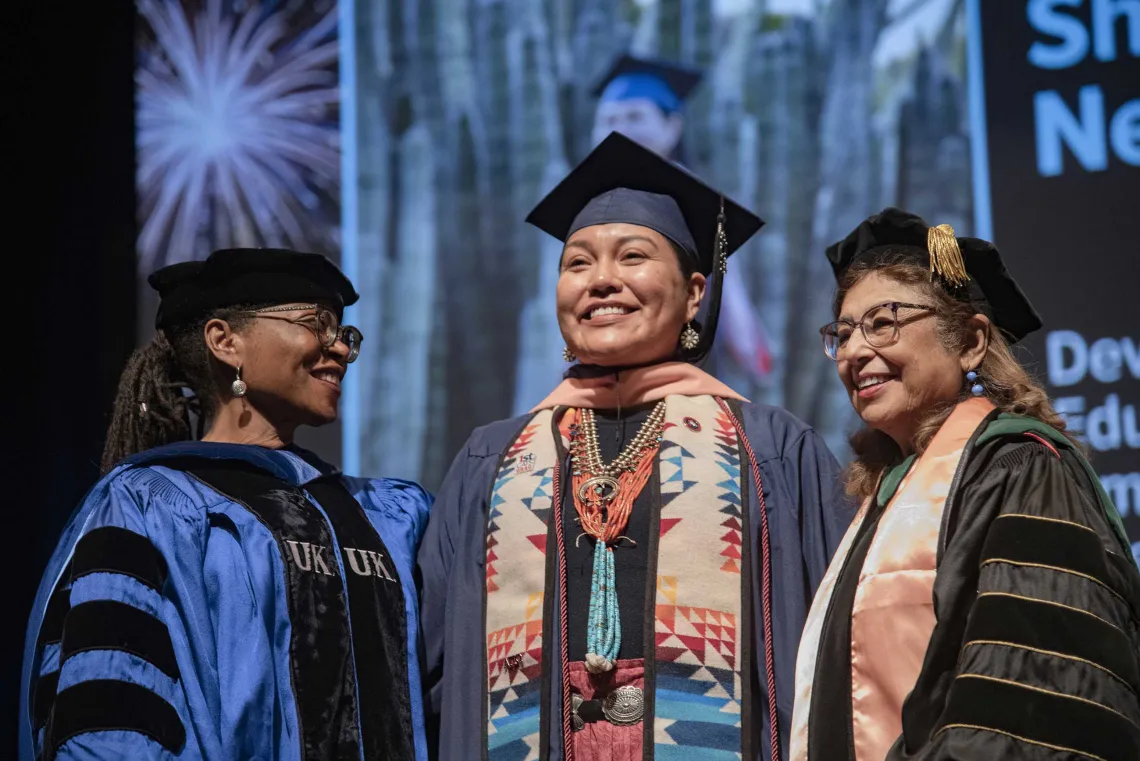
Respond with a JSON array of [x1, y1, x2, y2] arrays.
[[19, 442, 431, 761]]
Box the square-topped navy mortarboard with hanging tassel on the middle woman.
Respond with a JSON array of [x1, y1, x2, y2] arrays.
[[527, 132, 764, 361]]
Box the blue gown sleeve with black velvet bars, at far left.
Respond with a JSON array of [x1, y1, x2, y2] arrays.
[[21, 468, 212, 759]]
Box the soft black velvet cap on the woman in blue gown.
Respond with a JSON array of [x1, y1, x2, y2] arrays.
[[147, 248, 360, 329]]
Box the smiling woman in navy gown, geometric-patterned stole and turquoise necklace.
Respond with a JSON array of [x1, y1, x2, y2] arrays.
[[418, 134, 854, 761]]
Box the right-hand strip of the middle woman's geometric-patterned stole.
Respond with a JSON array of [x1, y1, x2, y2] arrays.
[[652, 396, 749, 760]]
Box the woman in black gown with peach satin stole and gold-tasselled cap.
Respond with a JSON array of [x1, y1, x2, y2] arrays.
[[791, 208, 1140, 761]]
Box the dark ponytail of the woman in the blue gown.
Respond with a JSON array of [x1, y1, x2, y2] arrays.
[[101, 304, 262, 473]]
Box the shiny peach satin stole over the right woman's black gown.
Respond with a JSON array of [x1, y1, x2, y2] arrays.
[[789, 399, 993, 761]]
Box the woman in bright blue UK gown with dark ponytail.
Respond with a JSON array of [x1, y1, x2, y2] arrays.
[[19, 248, 430, 761]]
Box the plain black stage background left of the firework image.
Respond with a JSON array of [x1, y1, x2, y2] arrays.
[[7, 0, 136, 759]]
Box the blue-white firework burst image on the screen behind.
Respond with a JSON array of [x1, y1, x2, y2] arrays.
[[136, 0, 340, 273]]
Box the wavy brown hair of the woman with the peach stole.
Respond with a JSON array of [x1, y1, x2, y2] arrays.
[[833, 251, 1083, 498]]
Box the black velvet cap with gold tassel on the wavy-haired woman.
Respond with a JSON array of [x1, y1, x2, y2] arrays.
[[827, 207, 1041, 342]]
